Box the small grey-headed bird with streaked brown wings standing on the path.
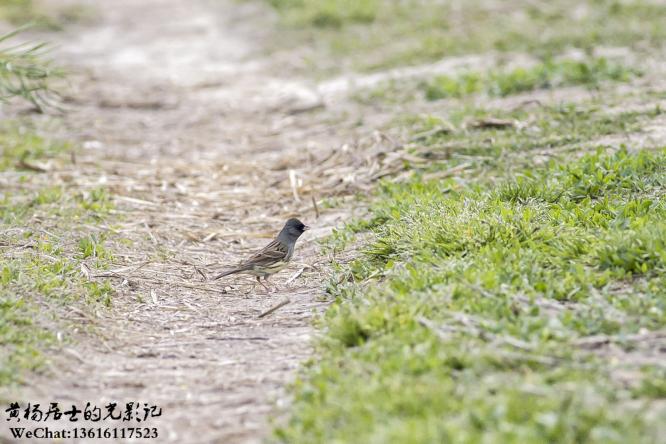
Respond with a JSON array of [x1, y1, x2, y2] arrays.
[[213, 218, 310, 291]]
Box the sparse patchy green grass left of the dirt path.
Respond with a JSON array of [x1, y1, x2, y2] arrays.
[[0, 122, 113, 386]]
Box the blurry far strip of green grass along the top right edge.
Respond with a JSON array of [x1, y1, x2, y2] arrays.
[[267, 0, 666, 72]]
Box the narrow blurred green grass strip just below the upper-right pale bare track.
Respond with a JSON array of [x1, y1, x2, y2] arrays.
[[421, 58, 639, 100]]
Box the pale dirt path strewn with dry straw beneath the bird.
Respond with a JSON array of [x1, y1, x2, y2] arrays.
[[2, 0, 364, 443]]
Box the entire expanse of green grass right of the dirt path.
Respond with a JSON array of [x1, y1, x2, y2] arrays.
[[271, 0, 666, 444]]
